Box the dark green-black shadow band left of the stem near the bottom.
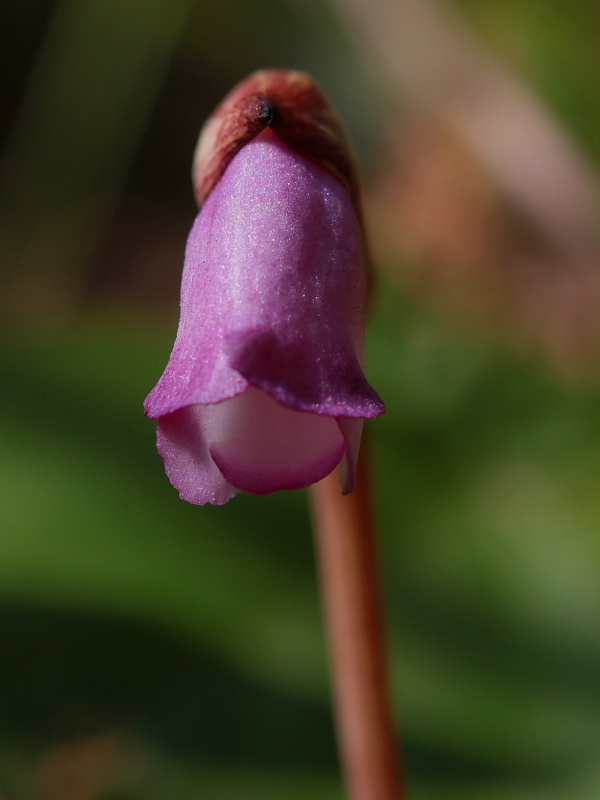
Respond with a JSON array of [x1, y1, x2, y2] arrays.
[[0, 604, 336, 771]]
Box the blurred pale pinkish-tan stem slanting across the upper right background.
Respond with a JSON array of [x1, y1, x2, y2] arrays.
[[334, 0, 600, 254]]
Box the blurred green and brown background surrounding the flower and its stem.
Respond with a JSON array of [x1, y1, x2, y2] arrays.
[[0, 0, 600, 800]]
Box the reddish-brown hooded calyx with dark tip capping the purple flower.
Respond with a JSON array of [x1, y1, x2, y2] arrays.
[[192, 70, 362, 219]]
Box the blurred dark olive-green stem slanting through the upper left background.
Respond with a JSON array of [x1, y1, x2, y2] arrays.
[[0, 0, 193, 318]]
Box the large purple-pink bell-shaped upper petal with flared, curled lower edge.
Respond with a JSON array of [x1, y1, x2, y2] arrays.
[[146, 130, 384, 418]]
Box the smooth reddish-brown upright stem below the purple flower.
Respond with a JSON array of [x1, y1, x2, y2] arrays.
[[312, 442, 406, 800]]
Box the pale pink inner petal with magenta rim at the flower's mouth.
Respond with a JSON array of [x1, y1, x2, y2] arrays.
[[209, 388, 345, 494]]
